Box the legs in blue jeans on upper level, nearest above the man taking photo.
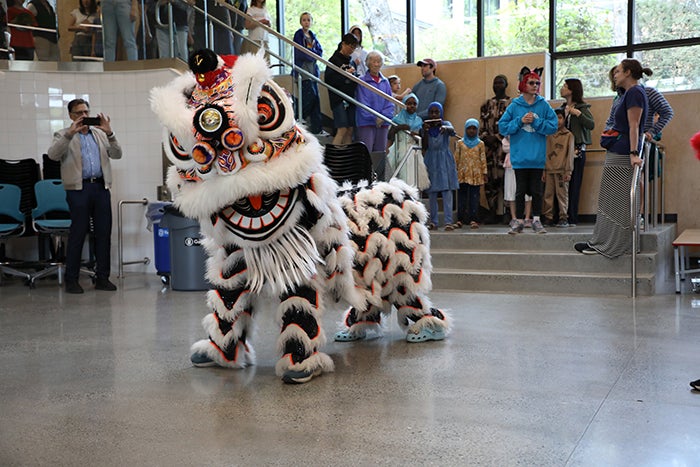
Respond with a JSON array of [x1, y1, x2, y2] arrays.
[[102, 0, 138, 62]]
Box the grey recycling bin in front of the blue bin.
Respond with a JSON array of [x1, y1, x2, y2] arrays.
[[160, 206, 211, 290]]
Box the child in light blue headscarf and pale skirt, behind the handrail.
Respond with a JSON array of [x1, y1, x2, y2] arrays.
[[387, 93, 430, 190]]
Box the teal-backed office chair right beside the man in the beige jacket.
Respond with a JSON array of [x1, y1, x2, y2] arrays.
[[29, 180, 71, 288]]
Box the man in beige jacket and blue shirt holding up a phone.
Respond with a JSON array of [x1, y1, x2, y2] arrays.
[[48, 99, 122, 294]]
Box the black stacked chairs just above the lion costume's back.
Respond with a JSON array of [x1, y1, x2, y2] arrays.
[[323, 141, 375, 184]]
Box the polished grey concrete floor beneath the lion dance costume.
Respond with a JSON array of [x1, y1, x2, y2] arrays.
[[0, 273, 700, 467]]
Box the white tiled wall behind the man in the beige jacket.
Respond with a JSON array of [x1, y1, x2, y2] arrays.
[[0, 70, 180, 276]]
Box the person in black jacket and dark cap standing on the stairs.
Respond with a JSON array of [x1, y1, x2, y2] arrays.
[[324, 34, 358, 144]]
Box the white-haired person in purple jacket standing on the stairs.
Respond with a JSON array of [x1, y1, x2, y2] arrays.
[[355, 50, 394, 152]]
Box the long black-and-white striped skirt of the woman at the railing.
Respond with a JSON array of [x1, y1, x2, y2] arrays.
[[588, 152, 639, 258]]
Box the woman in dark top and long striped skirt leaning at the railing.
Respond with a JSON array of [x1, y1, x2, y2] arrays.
[[574, 58, 651, 258]]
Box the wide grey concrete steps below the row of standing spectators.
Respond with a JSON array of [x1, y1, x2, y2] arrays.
[[431, 224, 676, 296]]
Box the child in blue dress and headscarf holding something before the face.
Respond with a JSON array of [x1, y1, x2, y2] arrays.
[[421, 102, 459, 231]]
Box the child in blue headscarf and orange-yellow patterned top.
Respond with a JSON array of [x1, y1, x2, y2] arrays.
[[455, 118, 488, 229]]
